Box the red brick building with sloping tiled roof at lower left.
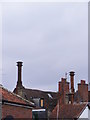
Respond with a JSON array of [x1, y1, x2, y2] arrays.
[[0, 86, 34, 120]]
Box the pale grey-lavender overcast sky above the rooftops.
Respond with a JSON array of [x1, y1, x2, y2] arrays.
[[2, 2, 88, 91]]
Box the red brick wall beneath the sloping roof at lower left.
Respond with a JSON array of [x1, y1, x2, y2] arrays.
[[2, 105, 32, 118]]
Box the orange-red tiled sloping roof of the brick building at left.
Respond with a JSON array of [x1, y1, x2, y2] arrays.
[[0, 86, 34, 106]]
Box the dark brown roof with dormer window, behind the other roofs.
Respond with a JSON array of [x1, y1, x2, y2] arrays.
[[14, 88, 57, 111]]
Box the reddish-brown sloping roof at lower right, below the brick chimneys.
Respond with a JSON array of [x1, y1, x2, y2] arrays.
[[50, 103, 87, 119]]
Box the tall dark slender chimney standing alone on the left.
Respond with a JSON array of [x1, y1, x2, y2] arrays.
[[17, 61, 23, 88]]
